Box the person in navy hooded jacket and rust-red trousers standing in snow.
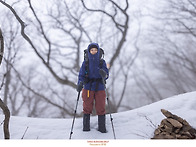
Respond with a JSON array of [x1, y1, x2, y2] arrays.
[[77, 43, 109, 133]]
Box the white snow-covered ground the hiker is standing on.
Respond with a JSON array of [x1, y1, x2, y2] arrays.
[[0, 92, 196, 139]]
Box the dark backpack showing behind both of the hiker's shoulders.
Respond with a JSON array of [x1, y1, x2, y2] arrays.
[[84, 48, 104, 81]]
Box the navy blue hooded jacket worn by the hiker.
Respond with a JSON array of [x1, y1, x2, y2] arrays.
[[78, 43, 109, 91]]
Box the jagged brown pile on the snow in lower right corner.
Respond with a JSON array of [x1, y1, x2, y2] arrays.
[[152, 109, 196, 139]]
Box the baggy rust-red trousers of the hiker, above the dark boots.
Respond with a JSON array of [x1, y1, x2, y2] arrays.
[[82, 89, 106, 115]]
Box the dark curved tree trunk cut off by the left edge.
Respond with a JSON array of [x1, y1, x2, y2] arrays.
[[0, 29, 10, 139]]
